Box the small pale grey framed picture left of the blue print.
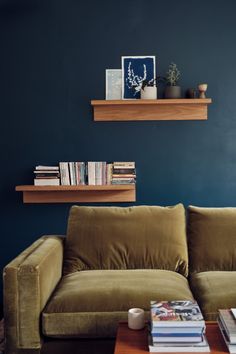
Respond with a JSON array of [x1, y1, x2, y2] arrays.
[[106, 69, 122, 100]]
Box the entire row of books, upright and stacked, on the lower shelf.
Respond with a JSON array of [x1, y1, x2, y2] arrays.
[[34, 161, 136, 186]]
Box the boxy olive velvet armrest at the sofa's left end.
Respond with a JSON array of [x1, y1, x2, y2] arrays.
[[3, 235, 65, 353]]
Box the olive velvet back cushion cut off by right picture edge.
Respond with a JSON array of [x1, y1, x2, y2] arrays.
[[188, 206, 236, 272]]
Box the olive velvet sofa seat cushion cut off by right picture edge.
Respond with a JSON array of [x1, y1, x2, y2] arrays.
[[190, 271, 236, 321]]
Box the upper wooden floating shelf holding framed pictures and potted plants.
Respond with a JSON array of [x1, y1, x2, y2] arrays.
[[91, 98, 212, 121]]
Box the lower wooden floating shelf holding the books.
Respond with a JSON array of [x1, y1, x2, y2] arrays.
[[15, 184, 136, 203]]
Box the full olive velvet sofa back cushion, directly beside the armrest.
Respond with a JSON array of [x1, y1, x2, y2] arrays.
[[64, 204, 188, 276]]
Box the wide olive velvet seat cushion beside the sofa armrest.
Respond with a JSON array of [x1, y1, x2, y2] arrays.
[[42, 270, 193, 337]]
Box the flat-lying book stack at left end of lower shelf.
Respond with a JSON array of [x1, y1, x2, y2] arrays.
[[34, 166, 60, 186]]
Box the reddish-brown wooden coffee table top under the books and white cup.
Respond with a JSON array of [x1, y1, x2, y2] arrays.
[[114, 322, 229, 354]]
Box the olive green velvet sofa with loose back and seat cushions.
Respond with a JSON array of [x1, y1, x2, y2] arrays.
[[4, 204, 236, 354]]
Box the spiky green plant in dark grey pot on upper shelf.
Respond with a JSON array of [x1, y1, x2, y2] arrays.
[[165, 63, 181, 98]]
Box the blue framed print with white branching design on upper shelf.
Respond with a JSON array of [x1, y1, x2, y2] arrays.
[[121, 56, 156, 99]]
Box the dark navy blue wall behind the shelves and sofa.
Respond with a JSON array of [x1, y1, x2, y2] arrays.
[[0, 0, 236, 304]]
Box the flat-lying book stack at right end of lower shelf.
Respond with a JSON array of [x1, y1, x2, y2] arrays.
[[112, 162, 136, 184]]
